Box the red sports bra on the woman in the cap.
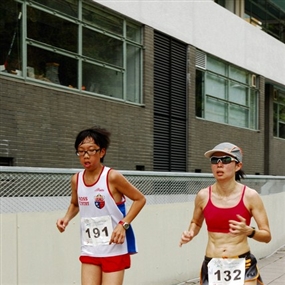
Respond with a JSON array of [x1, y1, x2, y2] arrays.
[[203, 186, 251, 233]]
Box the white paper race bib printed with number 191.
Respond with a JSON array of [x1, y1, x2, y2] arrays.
[[81, 216, 113, 246]]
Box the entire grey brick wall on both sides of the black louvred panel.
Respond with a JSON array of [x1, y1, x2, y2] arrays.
[[0, 29, 285, 175]]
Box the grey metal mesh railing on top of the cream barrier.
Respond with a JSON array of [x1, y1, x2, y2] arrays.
[[0, 166, 285, 213]]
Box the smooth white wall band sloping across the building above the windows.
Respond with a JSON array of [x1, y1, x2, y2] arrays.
[[95, 0, 285, 85]]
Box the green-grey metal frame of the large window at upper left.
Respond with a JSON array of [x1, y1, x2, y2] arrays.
[[3, 0, 143, 105]]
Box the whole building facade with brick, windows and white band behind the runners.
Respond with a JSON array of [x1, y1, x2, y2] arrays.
[[0, 0, 285, 175]]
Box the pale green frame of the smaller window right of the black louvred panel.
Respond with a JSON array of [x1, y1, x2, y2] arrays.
[[196, 51, 259, 130]]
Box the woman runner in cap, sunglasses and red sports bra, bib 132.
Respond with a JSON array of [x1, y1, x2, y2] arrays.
[[180, 142, 271, 285]]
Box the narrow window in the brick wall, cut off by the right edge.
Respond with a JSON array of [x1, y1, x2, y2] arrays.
[[273, 89, 285, 139]]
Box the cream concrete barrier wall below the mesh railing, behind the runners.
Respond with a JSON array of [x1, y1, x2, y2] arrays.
[[0, 192, 285, 285]]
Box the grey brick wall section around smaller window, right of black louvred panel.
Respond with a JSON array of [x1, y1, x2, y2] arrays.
[[188, 47, 270, 174]]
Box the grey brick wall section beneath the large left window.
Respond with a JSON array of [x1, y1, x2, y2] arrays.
[[0, 67, 152, 170]]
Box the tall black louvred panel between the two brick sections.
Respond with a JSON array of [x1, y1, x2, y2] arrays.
[[154, 33, 187, 171]]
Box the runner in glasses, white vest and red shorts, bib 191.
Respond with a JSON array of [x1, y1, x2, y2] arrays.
[[56, 127, 146, 285]]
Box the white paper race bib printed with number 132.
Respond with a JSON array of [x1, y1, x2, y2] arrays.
[[208, 258, 245, 285]]
